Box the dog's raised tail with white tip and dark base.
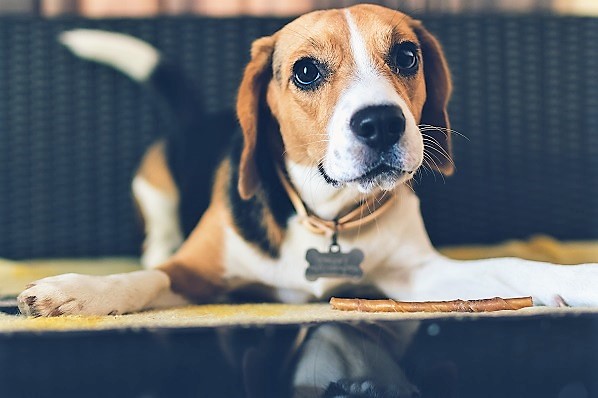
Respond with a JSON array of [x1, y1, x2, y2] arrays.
[[58, 29, 204, 129]]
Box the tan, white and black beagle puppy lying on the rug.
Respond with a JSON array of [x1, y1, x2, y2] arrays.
[[18, 4, 598, 316]]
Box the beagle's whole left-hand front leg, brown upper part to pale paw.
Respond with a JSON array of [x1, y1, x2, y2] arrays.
[[18, 202, 229, 316]]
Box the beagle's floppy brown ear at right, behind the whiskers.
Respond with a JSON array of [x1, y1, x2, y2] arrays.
[[413, 21, 454, 175]]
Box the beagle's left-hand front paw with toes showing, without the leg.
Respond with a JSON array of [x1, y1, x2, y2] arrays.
[[17, 274, 118, 317]]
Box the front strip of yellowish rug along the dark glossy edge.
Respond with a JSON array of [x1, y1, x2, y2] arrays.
[[0, 304, 598, 333]]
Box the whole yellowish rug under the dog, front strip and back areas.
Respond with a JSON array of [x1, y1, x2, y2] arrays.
[[0, 236, 598, 333]]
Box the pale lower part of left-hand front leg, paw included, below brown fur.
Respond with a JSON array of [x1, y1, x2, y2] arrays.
[[18, 270, 185, 316]]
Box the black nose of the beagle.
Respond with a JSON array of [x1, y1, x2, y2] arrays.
[[349, 105, 405, 150]]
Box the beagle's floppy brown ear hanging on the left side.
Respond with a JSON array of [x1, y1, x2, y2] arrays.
[[237, 36, 275, 199]]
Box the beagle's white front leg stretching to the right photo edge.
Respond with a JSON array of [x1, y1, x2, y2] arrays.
[[378, 255, 598, 306]]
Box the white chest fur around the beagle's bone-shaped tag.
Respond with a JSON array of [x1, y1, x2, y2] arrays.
[[224, 193, 427, 302]]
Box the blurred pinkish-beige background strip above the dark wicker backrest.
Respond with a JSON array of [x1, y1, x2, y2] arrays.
[[0, 0, 598, 18]]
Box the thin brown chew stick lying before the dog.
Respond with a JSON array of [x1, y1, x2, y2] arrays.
[[330, 297, 534, 312]]
